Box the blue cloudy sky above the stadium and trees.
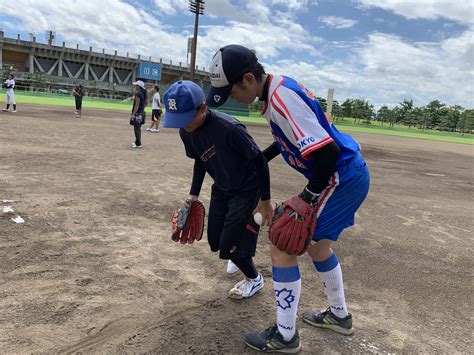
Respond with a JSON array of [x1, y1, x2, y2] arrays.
[[0, 0, 474, 108]]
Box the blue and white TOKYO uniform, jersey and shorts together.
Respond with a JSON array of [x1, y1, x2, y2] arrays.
[[263, 75, 370, 240]]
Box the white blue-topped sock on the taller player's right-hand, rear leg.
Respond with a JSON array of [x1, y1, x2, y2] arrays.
[[313, 253, 348, 318]]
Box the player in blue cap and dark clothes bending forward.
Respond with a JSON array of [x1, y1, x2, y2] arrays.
[[163, 80, 272, 299]]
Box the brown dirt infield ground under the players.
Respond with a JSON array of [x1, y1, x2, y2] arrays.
[[0, 101, 474, 354]]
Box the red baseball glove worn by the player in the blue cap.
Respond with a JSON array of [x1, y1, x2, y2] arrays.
[[171, 200, 206, 244]]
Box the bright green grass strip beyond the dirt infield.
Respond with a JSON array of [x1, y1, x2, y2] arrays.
[[7, 91, 474, 144]]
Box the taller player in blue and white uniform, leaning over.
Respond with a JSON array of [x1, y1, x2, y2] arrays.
[[206, 45, 370, 352]]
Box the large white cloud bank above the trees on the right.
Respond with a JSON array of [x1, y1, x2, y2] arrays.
[[269, 31, 474, 107]]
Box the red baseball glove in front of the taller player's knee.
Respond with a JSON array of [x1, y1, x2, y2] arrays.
[[269, 195, 316, 255]]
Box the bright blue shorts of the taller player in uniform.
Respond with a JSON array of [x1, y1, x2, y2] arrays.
[[313, 153, 370, 241]]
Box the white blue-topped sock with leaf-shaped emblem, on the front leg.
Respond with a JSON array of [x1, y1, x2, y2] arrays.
[[272, 265, 301, 340]]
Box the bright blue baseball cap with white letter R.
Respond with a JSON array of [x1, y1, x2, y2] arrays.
[[163, 80, 205, 128]]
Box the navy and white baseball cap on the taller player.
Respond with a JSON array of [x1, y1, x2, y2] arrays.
[[206, 44, 258, 107]]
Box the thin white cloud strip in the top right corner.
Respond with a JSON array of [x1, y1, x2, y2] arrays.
[[355, 0, 474, 24]]
